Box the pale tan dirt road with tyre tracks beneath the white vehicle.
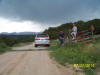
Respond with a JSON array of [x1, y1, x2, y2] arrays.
[[0, 44, 74, 75]]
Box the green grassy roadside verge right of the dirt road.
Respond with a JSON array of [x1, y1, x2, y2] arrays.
[[49, 36, 100, 75]]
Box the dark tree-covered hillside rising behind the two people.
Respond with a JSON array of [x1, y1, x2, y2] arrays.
[[44, 19, 100, 39]]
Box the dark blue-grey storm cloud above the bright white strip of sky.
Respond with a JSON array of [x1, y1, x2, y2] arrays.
[[0, 0, 100, 24]]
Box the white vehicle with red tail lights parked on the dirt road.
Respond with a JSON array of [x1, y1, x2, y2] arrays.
[[35, 33, 50, 47]]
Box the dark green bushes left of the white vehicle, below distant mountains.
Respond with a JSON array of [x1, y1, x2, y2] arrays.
[[0, 35, 34, 47]]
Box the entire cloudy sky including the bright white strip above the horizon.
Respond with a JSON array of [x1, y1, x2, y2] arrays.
[[0, 0, 100, 32]]
